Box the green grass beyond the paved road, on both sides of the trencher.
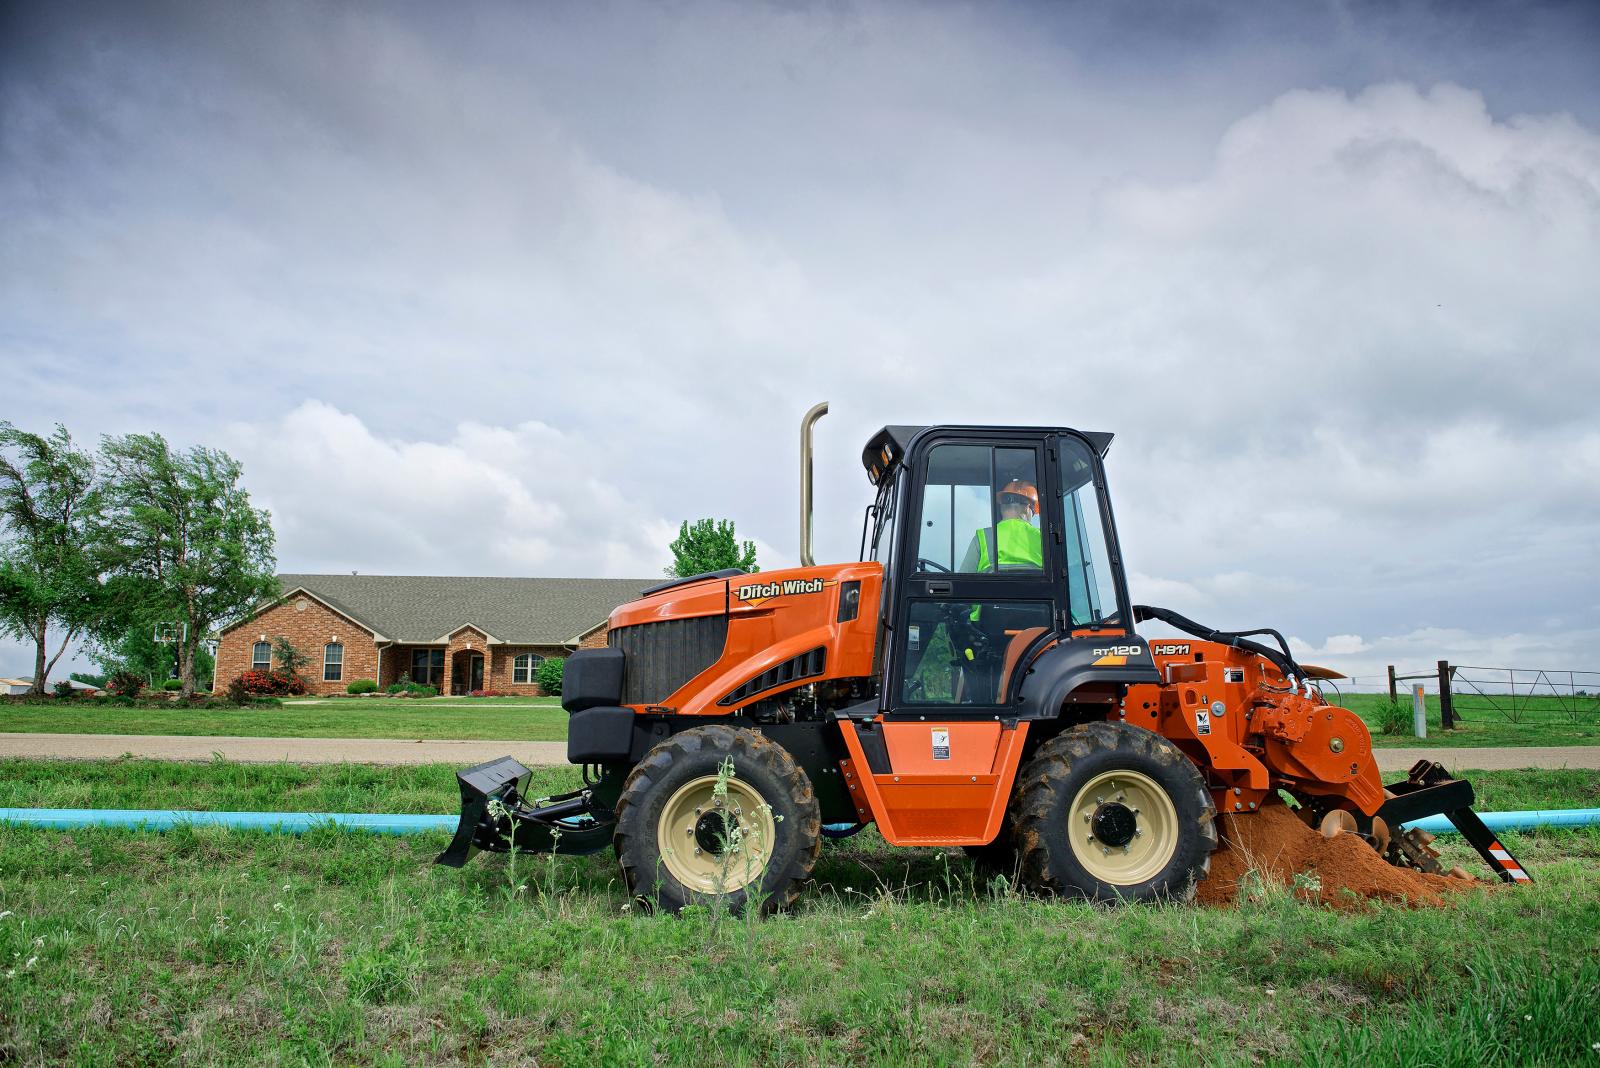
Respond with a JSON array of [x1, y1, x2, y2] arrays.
[[0, 692, 1600, 748]]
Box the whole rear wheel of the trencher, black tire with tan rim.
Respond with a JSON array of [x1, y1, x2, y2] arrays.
[[1013, 723, 1216, 902]]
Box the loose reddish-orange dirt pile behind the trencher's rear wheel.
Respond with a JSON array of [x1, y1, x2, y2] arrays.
[[1197, 804, 1482, 908]]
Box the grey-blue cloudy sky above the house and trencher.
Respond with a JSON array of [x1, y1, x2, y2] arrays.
[[0, 0, 1600, 675]]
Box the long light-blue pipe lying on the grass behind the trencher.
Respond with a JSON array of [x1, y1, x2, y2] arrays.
[[0, 809, 1600, 835]]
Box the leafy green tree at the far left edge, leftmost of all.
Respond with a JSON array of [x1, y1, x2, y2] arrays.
[[0, 420, 101, 694]]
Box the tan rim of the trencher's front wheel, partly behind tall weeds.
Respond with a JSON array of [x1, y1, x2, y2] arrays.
[[656, 775, 778, 894]]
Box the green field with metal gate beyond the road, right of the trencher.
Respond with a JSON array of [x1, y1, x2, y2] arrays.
[[1326, 691, 1600, 748]]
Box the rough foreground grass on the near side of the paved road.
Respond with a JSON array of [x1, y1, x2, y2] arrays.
[[0, 761, 1600, 1065]]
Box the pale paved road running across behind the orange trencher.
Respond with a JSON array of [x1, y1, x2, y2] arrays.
[[0, 734, 1600, 775]]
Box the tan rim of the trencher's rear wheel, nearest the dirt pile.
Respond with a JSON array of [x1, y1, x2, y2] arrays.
[[1067, 771, 1178, 886]]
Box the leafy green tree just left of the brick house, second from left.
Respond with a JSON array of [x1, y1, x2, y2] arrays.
[[99, 433, 278, 697]]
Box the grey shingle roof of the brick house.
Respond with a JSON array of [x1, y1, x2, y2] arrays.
[[268, 574, 659, 646]]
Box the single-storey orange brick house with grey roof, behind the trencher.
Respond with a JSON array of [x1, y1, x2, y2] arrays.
[[216, 574, 659, 697]]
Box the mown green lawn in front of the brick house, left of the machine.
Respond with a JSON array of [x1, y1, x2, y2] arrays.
[[0, 697, 566, 742]]
